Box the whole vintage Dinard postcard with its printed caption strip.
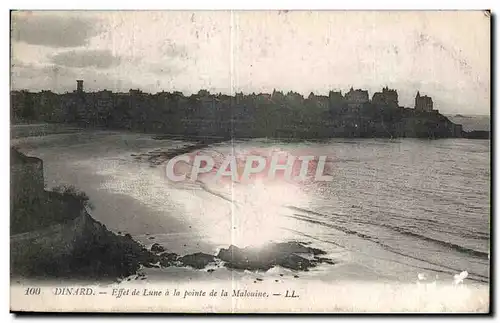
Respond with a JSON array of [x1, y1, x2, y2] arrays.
[[10, 10, 491, 313]]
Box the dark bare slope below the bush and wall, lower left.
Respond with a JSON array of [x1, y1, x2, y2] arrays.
[[10, 210, 155, 279]]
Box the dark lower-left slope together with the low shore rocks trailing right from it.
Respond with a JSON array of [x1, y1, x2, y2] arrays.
[[10, 211, 335, 280]]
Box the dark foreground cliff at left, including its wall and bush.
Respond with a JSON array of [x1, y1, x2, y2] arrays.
[[10, 149, 156, 279]]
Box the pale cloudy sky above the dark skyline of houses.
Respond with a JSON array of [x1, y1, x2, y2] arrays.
[[11, 11, 490, 114]]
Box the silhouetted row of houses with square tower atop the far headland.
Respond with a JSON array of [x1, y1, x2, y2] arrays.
[[11, 80, 437, 129]]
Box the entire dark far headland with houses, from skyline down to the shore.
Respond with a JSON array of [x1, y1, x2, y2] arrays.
[[11, 80, 490, 139]]
